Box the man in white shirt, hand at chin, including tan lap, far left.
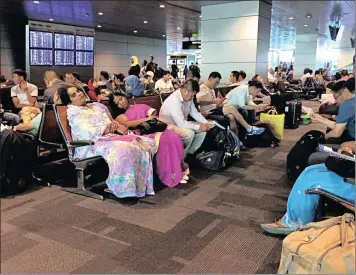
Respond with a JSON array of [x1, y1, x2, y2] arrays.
[[11, 70, 41, 123]]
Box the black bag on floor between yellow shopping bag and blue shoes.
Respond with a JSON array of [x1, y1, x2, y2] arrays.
[[240, 123, 281, 148]]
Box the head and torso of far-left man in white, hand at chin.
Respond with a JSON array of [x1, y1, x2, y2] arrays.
[[11, 70, 38, 109]]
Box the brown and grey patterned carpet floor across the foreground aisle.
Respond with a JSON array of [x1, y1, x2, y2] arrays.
[[1, 101, 325, 274]]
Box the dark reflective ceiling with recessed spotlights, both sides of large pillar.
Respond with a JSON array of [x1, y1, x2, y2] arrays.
[[0, 0, 355, 52]]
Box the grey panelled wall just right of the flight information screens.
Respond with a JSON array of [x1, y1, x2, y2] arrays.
[[94, 32, 167, 78]]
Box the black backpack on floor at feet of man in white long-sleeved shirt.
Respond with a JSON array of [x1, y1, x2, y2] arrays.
[[192, 126, 240, 171]]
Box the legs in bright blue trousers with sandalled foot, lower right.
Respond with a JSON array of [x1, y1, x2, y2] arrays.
[[261, 144, 355, 235]]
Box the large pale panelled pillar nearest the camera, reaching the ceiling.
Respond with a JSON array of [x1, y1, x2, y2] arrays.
[[200, 1, 272, 82]]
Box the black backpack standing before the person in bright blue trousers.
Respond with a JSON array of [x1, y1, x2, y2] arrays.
[[287, 130, 325, 182]]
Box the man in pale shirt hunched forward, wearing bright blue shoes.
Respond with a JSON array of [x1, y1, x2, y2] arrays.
[[223, 81, 268, 135]]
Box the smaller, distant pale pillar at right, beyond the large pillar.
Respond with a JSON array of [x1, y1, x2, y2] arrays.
[[294, 34, 329, 77]]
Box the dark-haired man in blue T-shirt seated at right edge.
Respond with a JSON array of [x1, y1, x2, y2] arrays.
[[325, 77, 356, 141]]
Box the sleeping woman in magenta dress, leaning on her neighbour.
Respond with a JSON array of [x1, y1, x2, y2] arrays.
[[113, 94, 189, 187]]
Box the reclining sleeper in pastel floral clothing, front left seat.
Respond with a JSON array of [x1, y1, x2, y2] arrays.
[[56, 88, 156, 198]]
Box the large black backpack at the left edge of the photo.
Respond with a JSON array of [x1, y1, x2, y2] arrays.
[[0, 129, 37, 196]]
